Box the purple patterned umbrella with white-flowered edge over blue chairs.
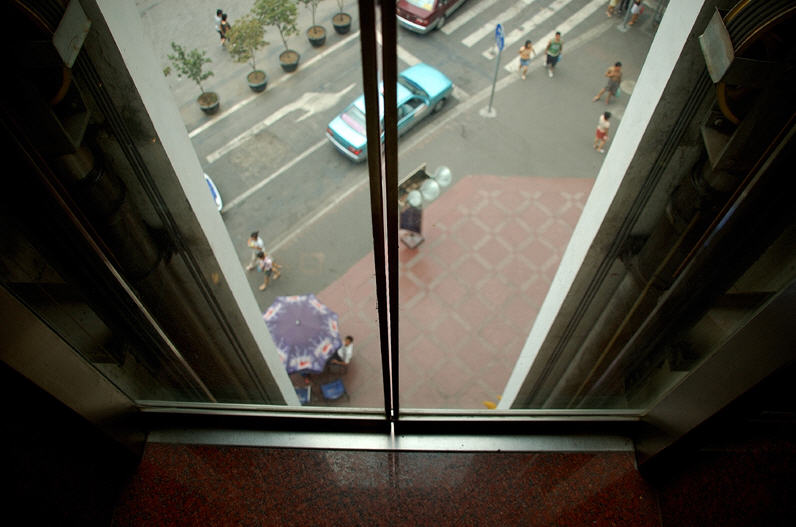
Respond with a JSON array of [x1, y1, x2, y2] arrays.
[[263, 294, 342, 373]]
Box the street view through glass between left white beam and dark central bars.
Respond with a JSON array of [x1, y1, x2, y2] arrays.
[[132, 0, 383, 408]]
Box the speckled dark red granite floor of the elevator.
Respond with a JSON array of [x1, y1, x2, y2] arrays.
[[113, 443, 661, 527]]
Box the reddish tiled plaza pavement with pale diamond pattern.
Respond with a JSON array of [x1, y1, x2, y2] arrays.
[[302, 176, 594, 409]]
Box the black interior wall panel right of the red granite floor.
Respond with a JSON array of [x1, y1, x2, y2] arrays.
[[641, 364, 796, 527]]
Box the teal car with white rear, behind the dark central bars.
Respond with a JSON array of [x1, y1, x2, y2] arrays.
[[326, 64, 453, 161]]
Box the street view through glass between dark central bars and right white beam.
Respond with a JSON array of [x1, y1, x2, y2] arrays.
[[397, 0, 656, 410]]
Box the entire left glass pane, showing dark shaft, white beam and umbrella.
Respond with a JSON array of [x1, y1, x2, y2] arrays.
[[2, 0, 383, 408]]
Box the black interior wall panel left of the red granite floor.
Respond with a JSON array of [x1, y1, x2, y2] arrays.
[[0, 362, 139, 525]]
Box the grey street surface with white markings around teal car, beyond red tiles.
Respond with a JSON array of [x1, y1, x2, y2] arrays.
[[137, 0, 654, 308]]
